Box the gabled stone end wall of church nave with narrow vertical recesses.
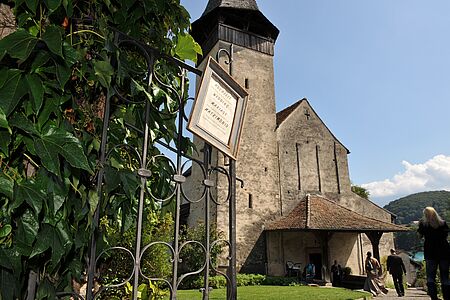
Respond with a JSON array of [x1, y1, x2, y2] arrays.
[[277, 100, 350, 214]]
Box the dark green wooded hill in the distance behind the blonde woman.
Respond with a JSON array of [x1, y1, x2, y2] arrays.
[[384, 191, 450, 224]]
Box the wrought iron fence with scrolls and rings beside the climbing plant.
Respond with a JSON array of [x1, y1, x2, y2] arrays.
[[53, 32, 237, 299]]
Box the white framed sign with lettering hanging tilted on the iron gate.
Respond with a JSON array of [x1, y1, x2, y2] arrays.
[[187, 57, 248, 159]]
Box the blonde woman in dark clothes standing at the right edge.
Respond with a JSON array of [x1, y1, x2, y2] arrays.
[[417, 207, 450, 300]]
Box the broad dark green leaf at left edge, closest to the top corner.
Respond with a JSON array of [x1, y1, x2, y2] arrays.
[[0, 28, 38, 61]]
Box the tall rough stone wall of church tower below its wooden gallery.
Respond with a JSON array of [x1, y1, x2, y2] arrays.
[[189, 41, 280, 273]]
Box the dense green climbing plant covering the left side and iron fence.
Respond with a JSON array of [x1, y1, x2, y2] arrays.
[[0, 0, 201, 299]]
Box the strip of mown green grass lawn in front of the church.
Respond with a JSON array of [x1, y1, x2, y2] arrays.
[[177, 285, 371, 300]]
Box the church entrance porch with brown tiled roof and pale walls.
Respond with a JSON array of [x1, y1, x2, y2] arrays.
[[265, 195, 408, 282]]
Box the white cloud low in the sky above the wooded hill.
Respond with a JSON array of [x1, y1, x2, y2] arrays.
[[361, 154, 450, 199]]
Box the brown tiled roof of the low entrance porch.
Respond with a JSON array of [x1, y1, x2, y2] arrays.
[[265, 194, 408, 232]]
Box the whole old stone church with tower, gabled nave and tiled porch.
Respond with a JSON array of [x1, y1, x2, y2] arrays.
[[184, 0, 404, 281]]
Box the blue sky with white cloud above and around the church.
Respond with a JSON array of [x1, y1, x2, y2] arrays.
[[181, 0, 450, 205]]
